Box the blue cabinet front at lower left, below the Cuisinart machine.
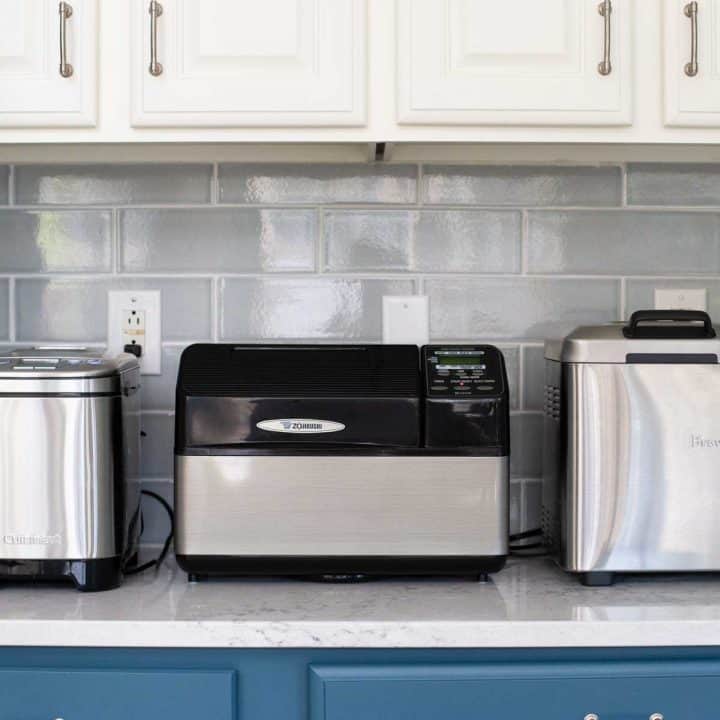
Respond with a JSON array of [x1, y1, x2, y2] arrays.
[[0, 668, 235, 720]]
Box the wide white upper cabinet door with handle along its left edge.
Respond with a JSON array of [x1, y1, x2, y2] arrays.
[[132, 0, 367, 127]]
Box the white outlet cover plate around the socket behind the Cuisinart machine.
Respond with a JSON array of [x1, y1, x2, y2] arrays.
[[108, 290, 162, 375]]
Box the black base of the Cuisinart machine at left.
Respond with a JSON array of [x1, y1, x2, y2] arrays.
[[0, 556, 123, 592]]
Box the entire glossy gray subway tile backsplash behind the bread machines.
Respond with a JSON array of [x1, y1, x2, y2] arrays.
[[0, 163, 720, 542]]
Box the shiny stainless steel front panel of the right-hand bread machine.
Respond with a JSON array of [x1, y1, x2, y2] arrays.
[[561, 364, 720, 571]]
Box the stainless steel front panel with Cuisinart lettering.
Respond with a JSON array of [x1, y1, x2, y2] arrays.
[[0, 396, 121, 559]]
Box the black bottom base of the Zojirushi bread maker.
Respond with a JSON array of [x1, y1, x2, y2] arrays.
[[177, 555, 507, 582]]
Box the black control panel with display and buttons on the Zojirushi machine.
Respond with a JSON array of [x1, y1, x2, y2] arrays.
[[423, 345, 505, 398]]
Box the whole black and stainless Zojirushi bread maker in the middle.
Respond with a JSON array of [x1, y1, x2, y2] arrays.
[[175, 345, 509, 579]]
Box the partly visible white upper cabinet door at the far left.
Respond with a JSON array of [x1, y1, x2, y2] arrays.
[[0, 0, 98, 127]]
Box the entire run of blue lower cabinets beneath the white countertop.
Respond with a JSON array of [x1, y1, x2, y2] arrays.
[[0, 648, 720, 720]]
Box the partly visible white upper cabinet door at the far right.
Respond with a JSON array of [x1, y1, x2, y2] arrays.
[[663, 0, 720, 127]]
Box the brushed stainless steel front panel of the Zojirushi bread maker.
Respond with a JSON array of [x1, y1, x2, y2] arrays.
[[175, 456, 508, 556]]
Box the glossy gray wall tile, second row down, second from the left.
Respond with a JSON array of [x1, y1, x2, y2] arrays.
[[120, 208, 317, 272]]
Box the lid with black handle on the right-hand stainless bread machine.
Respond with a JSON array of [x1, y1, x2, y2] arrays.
[[545, 310, 720, 363]]
